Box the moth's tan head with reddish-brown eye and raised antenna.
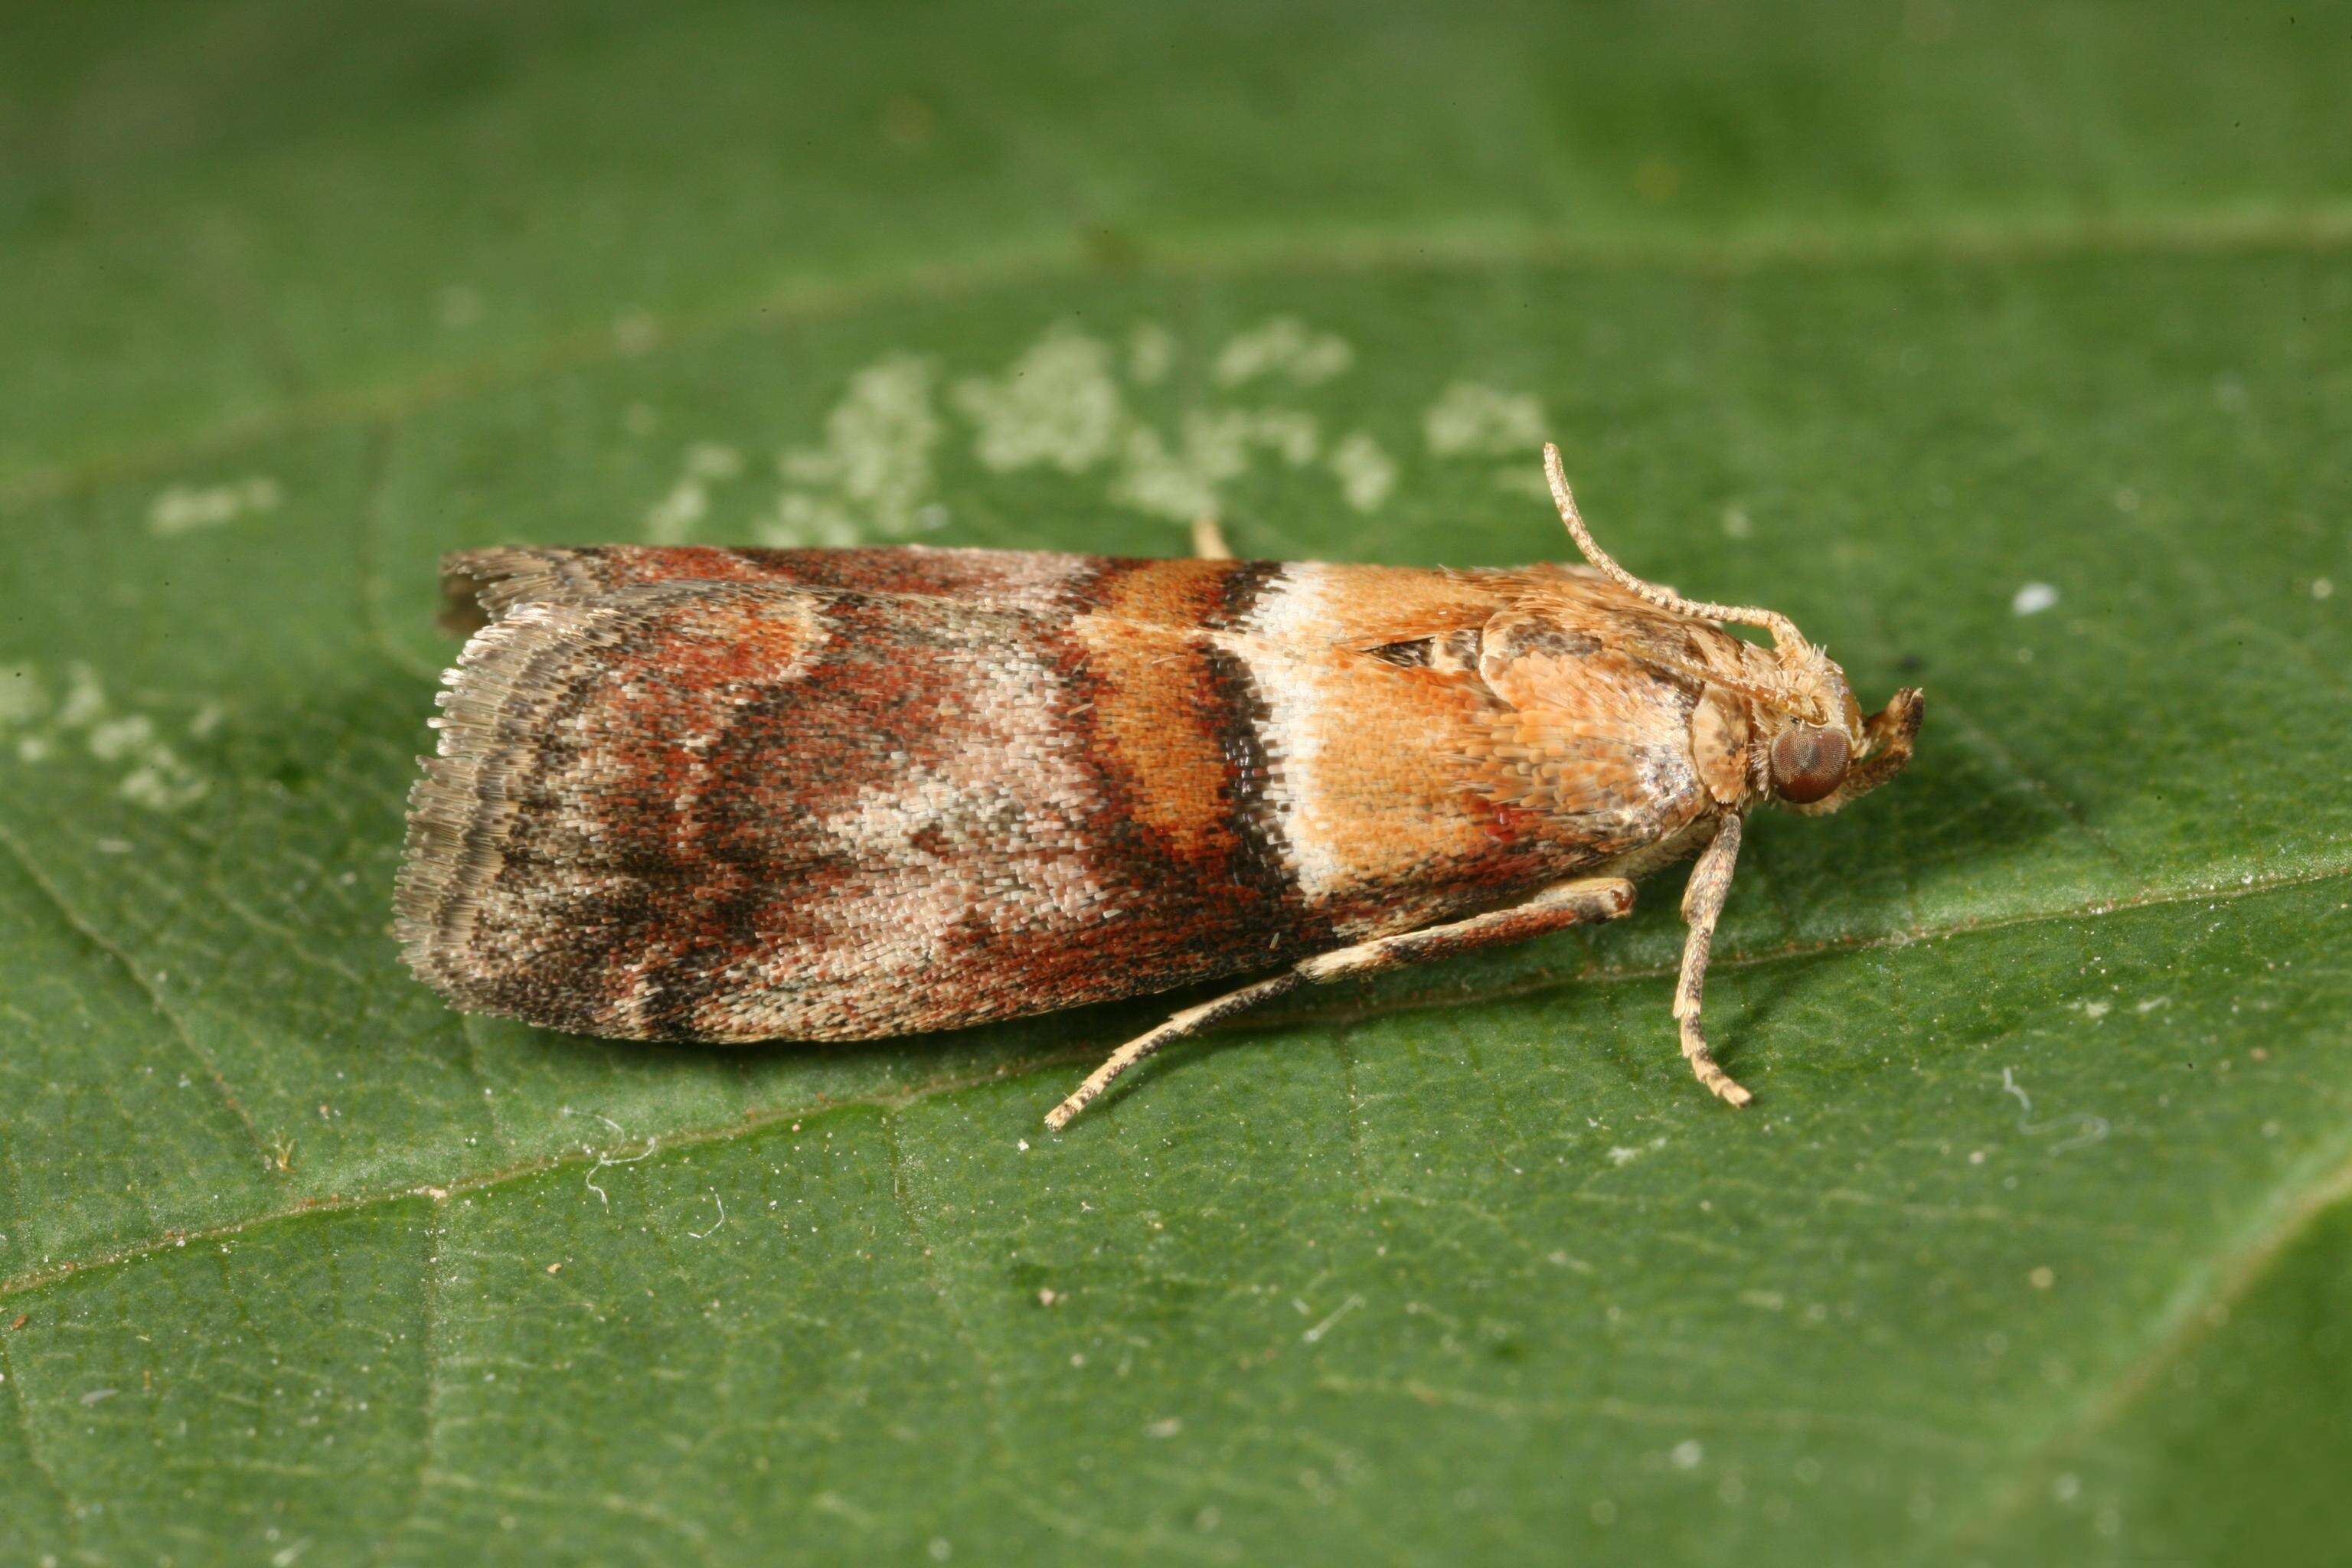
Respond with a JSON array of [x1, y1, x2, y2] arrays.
[[1543, 444, 1926, 815]]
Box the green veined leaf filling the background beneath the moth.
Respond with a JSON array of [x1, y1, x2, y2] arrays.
[[0, 2, 2352, 1563]]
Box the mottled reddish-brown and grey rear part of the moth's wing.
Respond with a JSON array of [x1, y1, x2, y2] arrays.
[[402, 578, 1327, 1039]]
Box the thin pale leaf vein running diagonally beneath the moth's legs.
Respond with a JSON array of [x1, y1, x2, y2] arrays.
[[0, 851, 2352, 1300]]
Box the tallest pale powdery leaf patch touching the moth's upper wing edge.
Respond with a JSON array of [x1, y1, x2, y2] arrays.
[[755, 355, 943, 547]]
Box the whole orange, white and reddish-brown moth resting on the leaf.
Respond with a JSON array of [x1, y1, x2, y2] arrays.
[[395, 446, 1924, 1131]]
